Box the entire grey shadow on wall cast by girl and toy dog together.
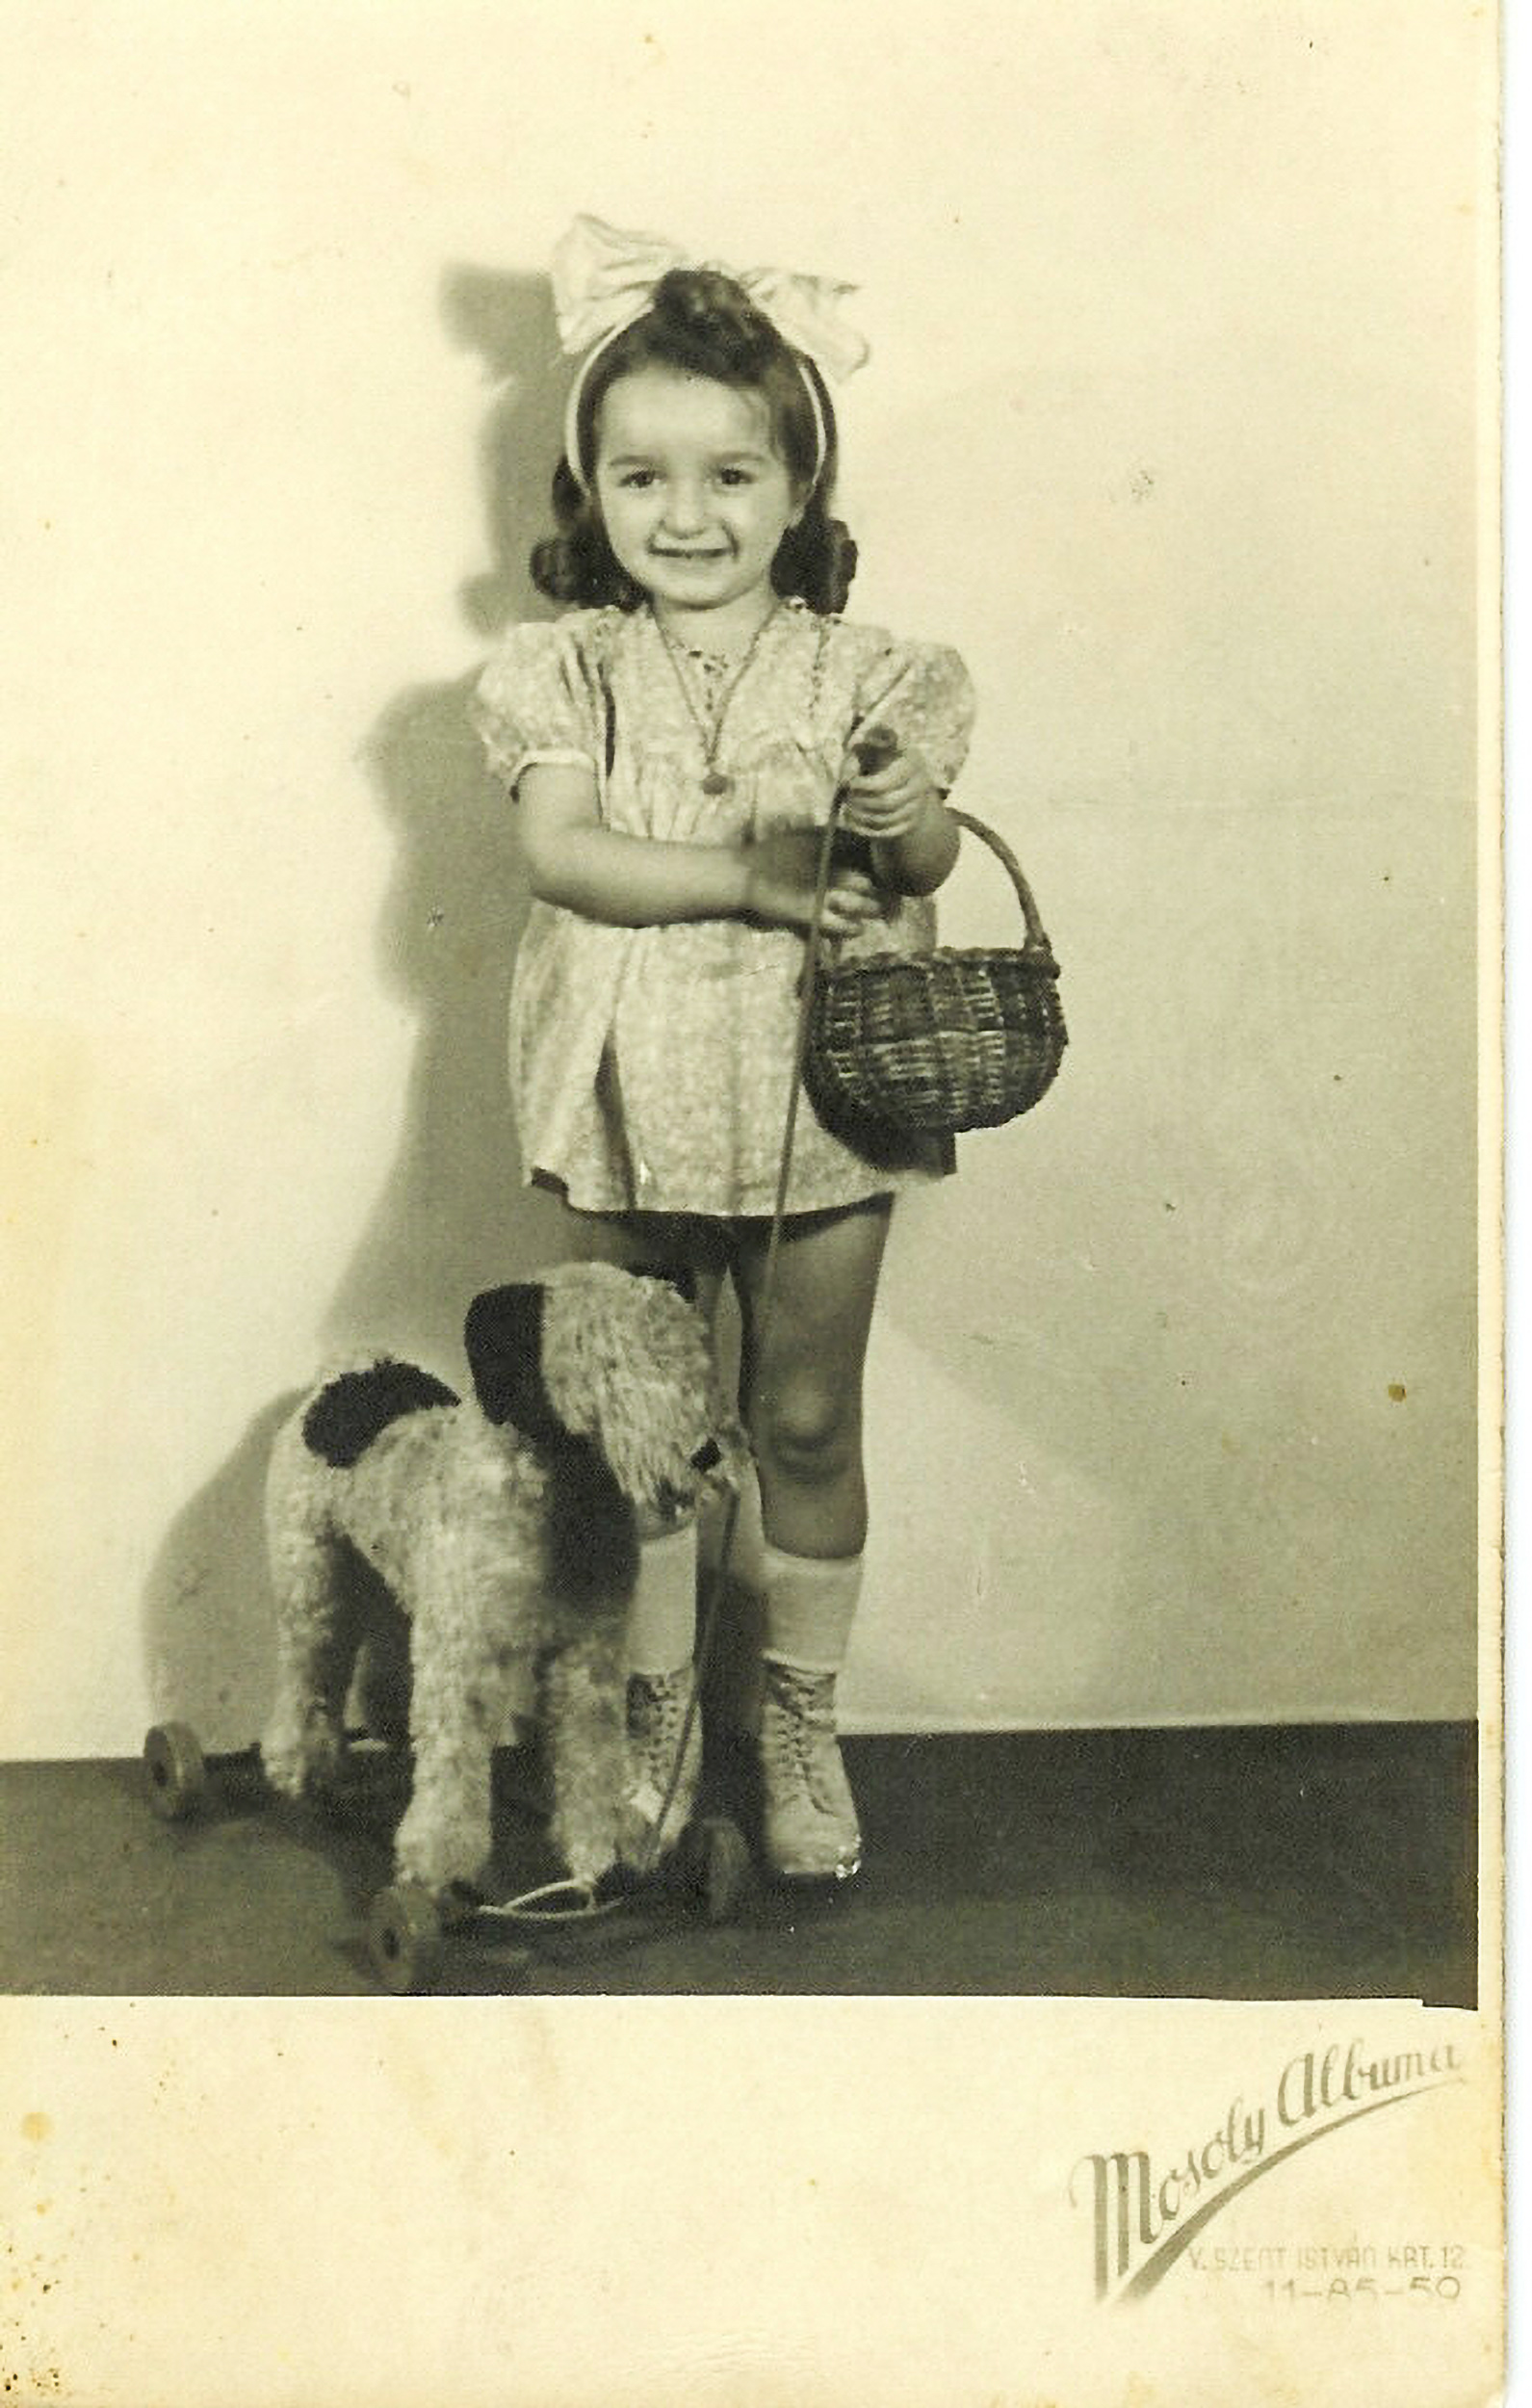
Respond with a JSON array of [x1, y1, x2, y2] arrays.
[[143, 268, 568, 1748]]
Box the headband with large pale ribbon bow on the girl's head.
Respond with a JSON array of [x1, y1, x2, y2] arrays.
[[554, 217, 868, 489]]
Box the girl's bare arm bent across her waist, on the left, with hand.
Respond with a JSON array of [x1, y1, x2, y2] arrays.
[[515, 761, 879, 937]]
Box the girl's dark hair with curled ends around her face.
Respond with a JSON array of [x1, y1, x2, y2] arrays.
[[532, 268, 858, 615]]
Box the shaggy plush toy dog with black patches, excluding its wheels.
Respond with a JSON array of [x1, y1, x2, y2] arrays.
[[260, 1265, 744, 1888]]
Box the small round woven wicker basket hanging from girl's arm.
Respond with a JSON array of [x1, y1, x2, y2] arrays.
[[802, 812, 1067, 1137]]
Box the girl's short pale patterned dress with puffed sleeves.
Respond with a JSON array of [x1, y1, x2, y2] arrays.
[[472, 602, 974, 1218]]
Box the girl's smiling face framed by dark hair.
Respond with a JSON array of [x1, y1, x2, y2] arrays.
[[595, 366, 805, 643]]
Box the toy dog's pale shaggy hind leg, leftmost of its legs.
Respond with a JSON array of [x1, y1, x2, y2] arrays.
[[260, 1530, 361, 1799]]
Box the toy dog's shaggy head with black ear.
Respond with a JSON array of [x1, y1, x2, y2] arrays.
[[462, 1262, 746, 1520]]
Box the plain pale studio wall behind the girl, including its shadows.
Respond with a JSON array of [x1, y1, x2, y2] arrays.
[[0, 0, 1493, 1756]]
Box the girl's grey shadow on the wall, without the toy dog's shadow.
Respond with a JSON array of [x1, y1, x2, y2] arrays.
[[325, 268, 566, 1380]]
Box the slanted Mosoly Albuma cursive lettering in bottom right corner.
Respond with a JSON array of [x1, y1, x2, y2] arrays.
[[1070, 2040, 1465, 2300]]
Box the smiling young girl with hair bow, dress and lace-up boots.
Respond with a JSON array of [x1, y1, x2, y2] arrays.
[[475, 220, 971, 1881]]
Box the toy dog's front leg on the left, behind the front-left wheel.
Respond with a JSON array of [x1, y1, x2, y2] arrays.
[[395, 1530, 522, 1888]]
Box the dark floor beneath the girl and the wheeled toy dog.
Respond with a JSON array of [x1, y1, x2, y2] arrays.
[[0, 1724, 1476, 2006]]
